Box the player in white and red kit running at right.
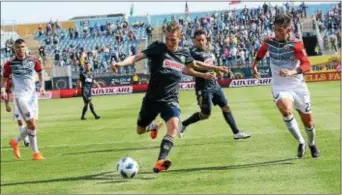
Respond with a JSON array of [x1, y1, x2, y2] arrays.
[[253, 14, 320, 158]]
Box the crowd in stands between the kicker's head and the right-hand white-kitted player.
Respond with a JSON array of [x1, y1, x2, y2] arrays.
[[163, 3, 316, 67]]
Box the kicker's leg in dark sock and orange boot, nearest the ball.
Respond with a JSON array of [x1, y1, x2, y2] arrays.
[[153, 103, 180, 173]]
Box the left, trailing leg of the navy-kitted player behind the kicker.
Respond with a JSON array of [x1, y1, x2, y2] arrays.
[[178, 90, 212, 138]]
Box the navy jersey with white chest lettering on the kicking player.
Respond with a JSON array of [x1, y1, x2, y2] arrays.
[[142, 41, 193, 102]]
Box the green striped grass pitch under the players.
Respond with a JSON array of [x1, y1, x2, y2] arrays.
[[1, 82, 341, 194]]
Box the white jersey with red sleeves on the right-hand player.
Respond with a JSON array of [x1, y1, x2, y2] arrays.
[[256, 37, 311, 89]]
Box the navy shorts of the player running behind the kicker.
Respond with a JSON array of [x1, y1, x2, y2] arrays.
[[196, 87, 228, 115]]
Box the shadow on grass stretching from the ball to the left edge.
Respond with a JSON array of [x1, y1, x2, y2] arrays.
[[0, 171, 128, 187]]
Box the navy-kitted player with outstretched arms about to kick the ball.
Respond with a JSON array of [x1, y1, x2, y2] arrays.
[[112, 23, 228, 173]]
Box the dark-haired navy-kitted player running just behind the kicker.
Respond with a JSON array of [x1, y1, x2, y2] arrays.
[[178, 30, 251, 139]]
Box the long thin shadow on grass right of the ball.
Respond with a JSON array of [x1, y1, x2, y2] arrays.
[[139, 158, 297, 174]]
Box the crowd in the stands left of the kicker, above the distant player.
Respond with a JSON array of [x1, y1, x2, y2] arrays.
[[36, 20, 153, 74]]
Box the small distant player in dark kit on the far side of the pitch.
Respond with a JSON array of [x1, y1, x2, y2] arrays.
[[76, 62, 101, 120]]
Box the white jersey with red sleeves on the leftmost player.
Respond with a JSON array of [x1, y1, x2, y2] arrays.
[[3, 56, 42, 98]]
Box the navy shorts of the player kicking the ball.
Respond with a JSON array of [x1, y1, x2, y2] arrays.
[[137, 97, 180, 127]]
